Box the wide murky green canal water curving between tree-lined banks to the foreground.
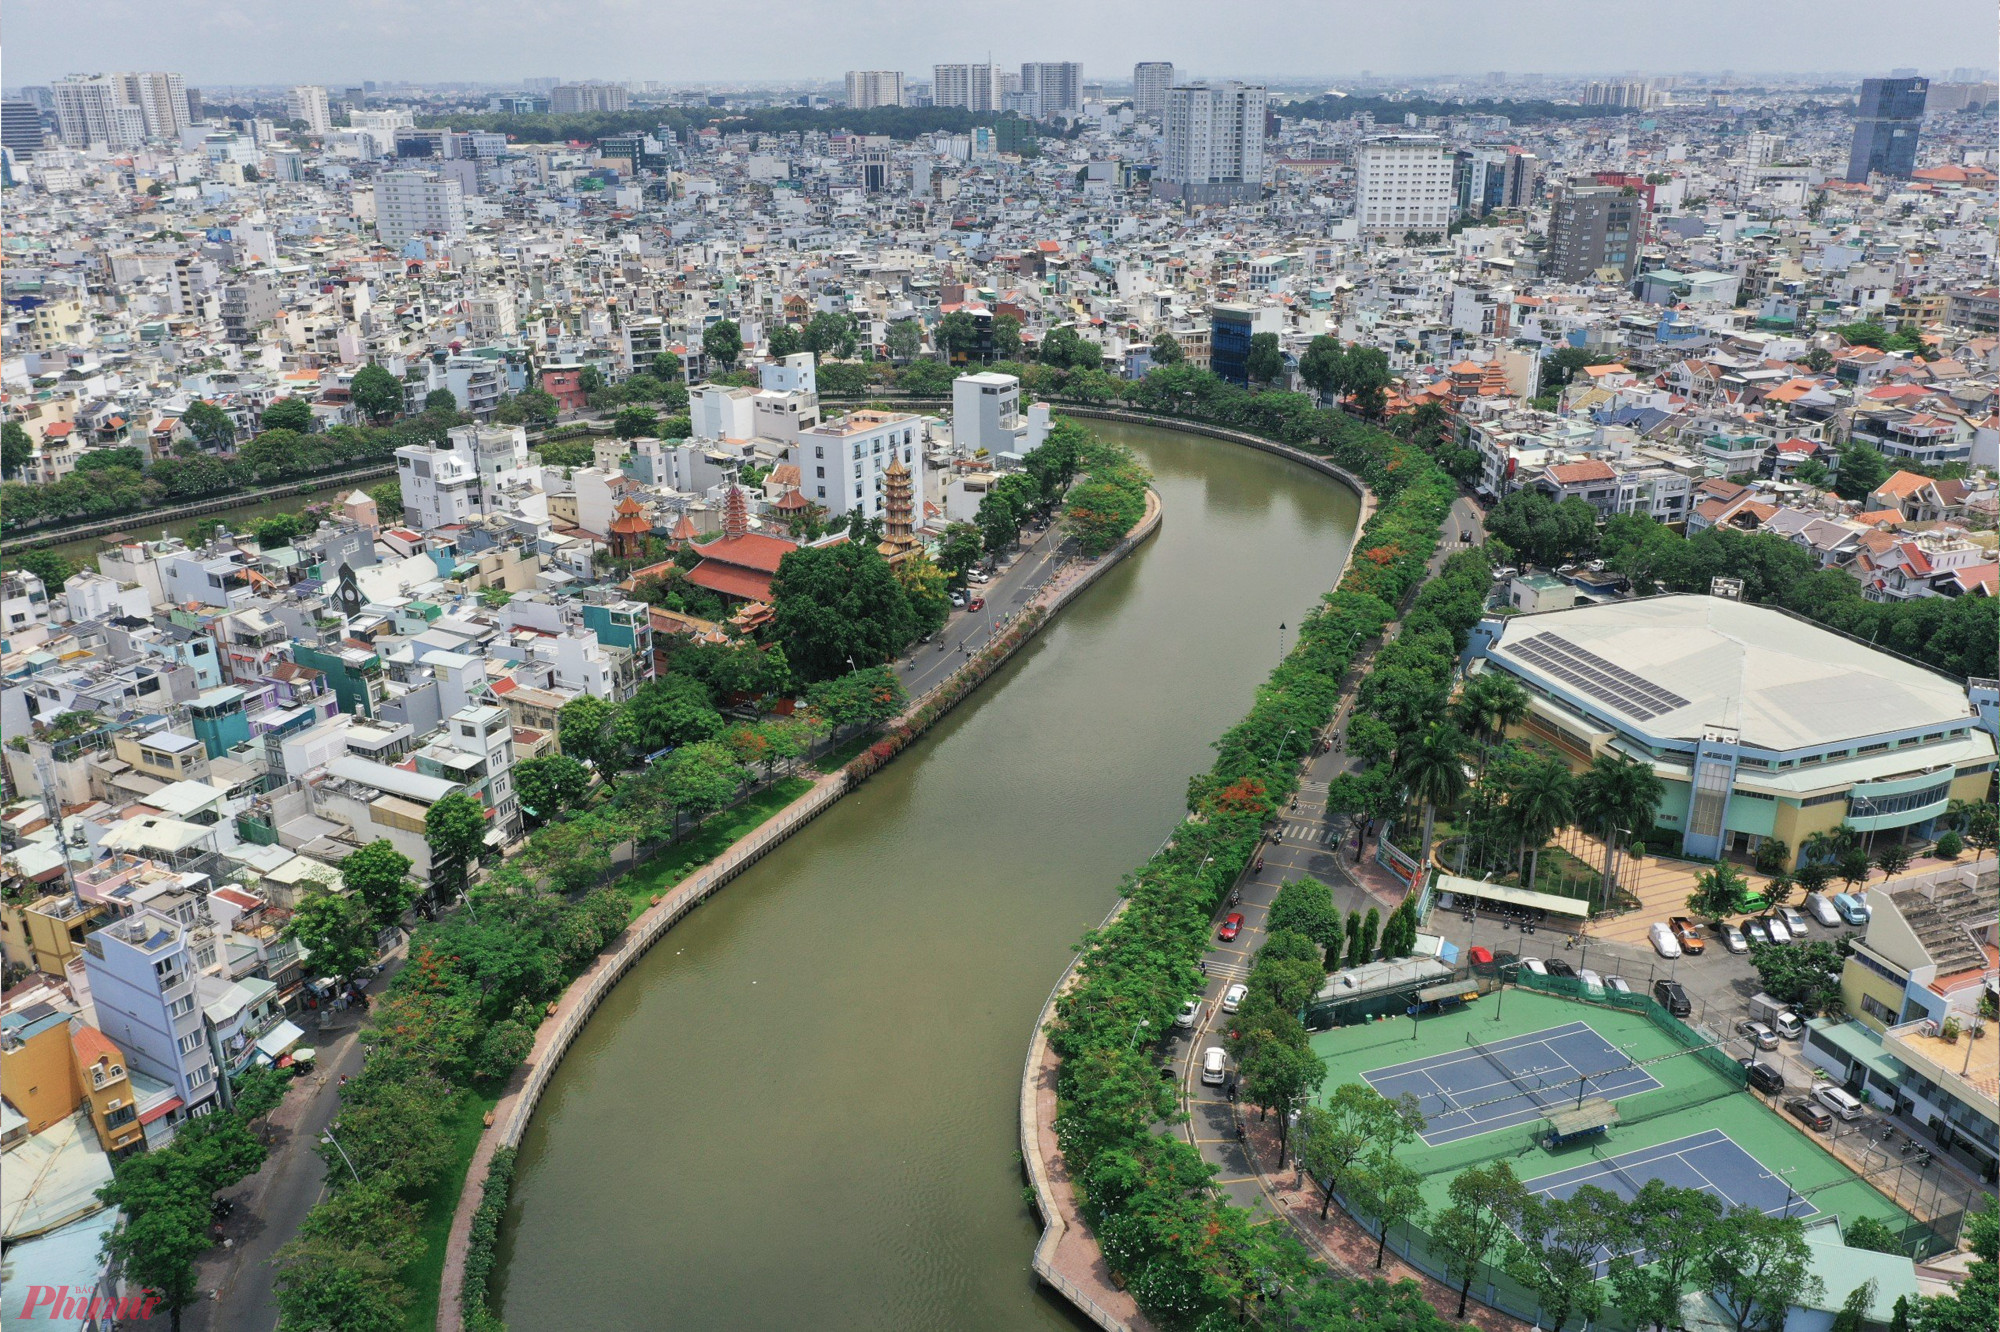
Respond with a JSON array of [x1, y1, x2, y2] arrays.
[[496, 422, 1358, 1330]]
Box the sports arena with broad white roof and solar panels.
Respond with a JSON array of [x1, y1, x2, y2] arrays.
[[1468, 596, 1994, 860]]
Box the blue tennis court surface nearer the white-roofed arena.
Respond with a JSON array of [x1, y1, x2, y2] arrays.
[[1362, 1022, 1660, 1146]]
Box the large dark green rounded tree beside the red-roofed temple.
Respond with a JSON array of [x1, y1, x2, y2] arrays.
[[770, 542, 916, 682]]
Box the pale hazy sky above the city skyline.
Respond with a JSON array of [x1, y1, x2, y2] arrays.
[[0, 0, 1996, 86]]
